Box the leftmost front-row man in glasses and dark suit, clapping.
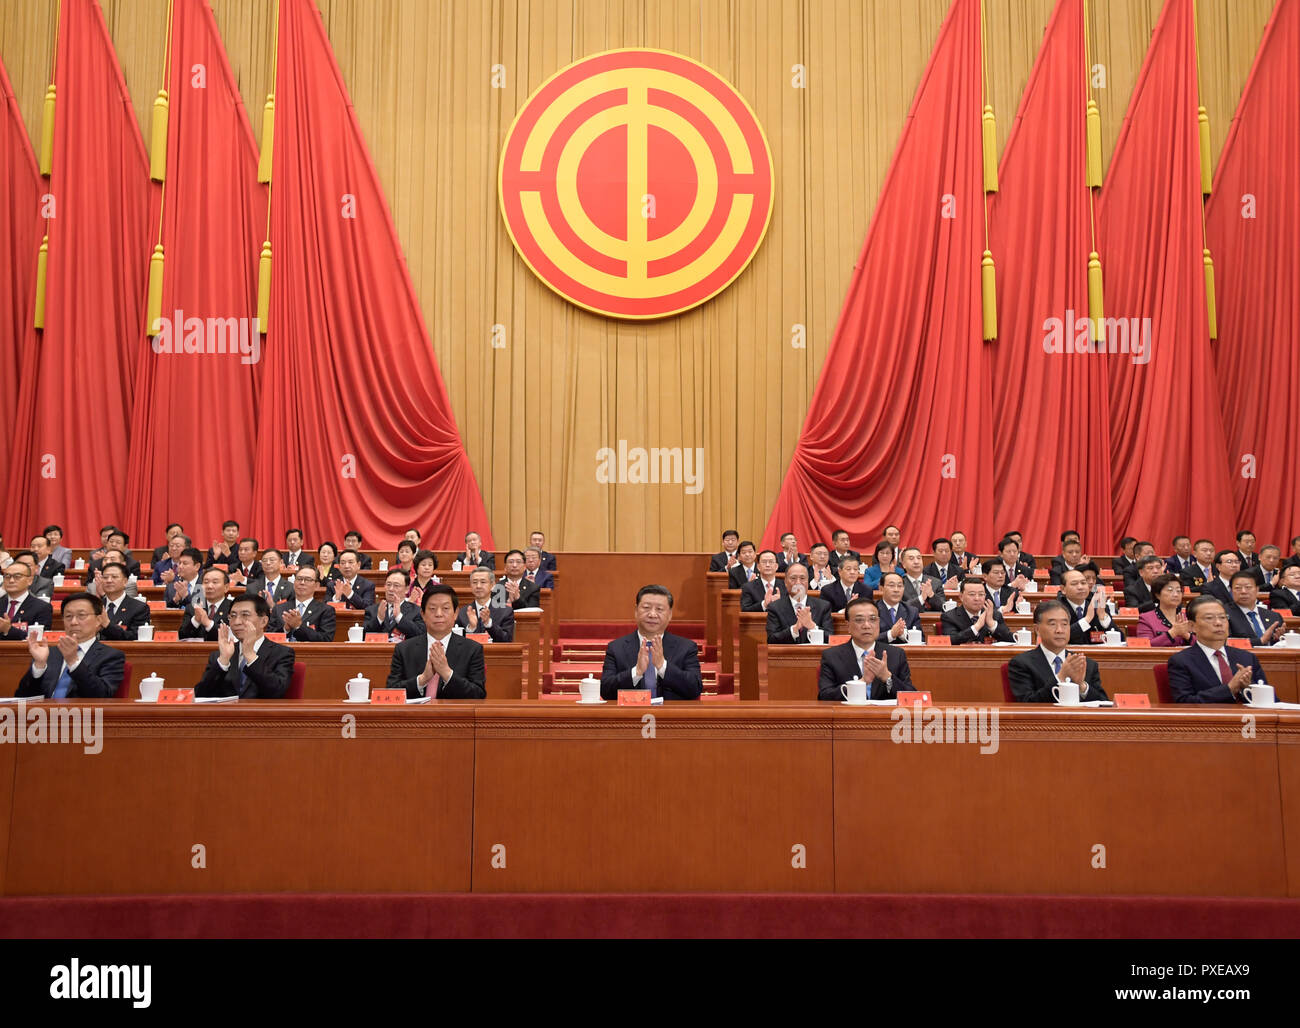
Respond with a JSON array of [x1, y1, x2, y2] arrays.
[[14, 593, 126, 699]]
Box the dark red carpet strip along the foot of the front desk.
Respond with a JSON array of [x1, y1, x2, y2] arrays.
[[0, 894, 1300, 938]]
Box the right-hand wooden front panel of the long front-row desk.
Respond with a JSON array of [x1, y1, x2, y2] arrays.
[[835, 704, 1287, 895]]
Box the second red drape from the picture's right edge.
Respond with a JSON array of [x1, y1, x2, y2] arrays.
[[1097, 0, 1234, 548]]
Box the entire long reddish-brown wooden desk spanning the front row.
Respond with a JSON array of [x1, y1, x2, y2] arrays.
[[0, 700, 1300, 897]]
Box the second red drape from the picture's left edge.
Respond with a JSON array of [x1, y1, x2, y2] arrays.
[[14, 0, 150, 546]]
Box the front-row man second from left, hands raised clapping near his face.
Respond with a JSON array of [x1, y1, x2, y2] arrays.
[[194, 593, 294, 699]]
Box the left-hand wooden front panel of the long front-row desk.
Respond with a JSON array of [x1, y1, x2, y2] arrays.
[[4, 702, 475, 895]]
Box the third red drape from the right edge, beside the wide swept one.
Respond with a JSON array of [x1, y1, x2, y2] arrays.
[[988, 0, 1114, 554]]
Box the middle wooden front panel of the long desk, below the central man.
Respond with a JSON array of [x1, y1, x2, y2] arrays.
[[473, 703, 833, 892]]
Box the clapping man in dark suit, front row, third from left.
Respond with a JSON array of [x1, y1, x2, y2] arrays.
[[387, 584, 488, 699]]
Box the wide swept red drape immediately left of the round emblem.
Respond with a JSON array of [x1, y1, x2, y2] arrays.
[[252, 0, 494, 548]]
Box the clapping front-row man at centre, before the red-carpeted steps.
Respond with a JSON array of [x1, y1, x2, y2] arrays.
[[601, 582, 702, 700]]
